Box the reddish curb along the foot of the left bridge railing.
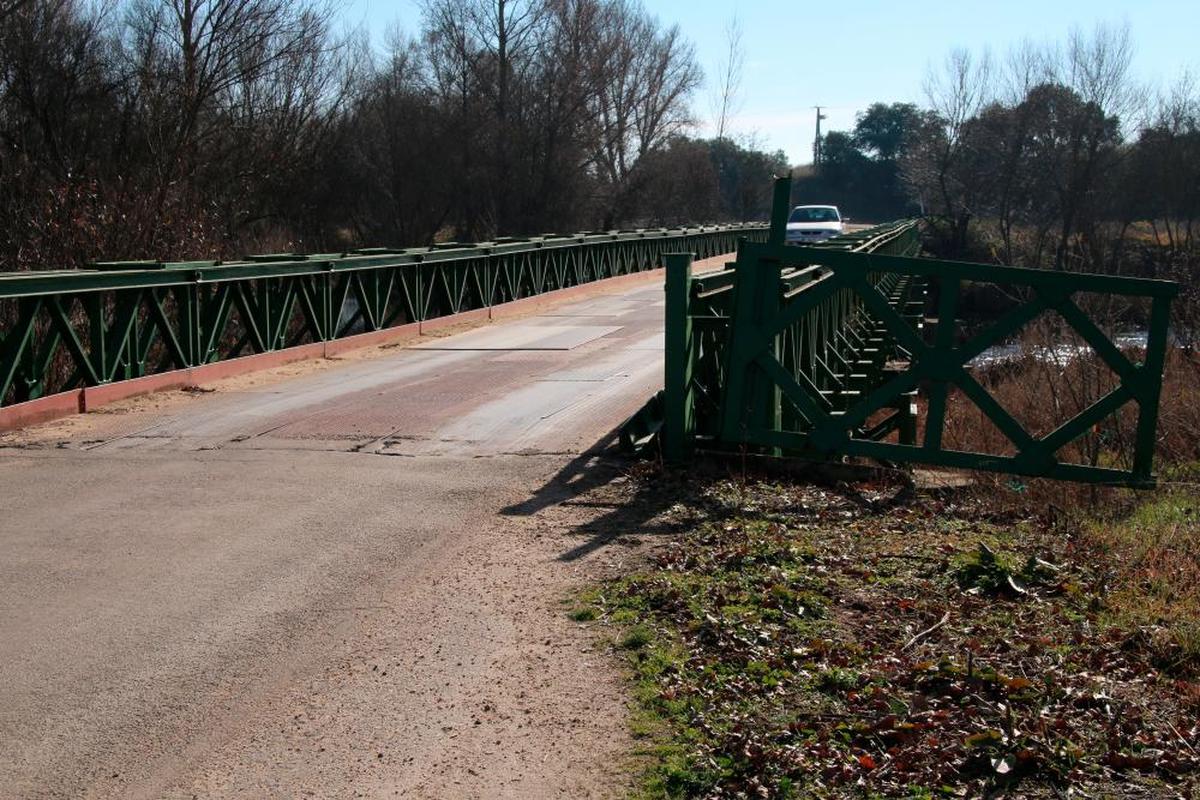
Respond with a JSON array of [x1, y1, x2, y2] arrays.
[[0, 263, 664, 432]]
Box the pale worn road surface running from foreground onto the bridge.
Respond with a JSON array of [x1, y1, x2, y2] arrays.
[[0, 267, 710, 798]]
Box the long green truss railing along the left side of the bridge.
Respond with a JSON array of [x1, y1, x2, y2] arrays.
[[0, 224, 767, 405]]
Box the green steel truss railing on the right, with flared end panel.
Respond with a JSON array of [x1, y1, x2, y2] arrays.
[[624, 179, 1178, 487]]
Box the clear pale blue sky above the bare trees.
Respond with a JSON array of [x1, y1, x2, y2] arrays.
[[344, 0, 1200, 163]]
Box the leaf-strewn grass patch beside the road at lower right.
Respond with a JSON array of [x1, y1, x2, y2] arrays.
[[576, 479, 1200, 798]]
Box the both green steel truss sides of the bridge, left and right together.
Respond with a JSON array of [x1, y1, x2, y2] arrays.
[[0, 179, 1177, 487]]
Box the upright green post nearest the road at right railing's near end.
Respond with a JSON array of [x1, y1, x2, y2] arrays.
[[662, 253, 695, 462]]
